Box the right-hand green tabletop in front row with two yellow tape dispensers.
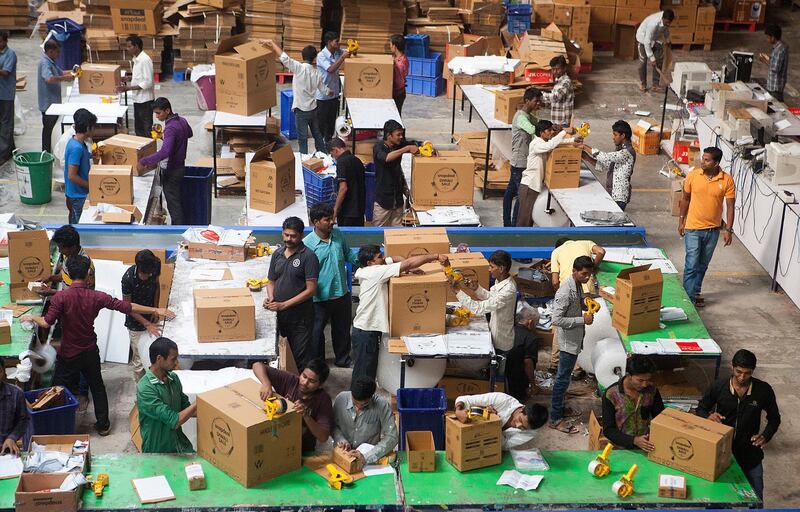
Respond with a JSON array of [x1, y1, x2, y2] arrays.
[[400, 450, 760, 509]]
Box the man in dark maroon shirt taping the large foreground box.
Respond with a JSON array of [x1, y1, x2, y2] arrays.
[[253, 359, 333, 452]]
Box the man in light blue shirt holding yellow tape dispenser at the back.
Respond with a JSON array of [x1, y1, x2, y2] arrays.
[[316, 31, 350, 144]]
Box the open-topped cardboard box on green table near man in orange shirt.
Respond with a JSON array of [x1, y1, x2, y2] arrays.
[[611, 265, 664, 335]]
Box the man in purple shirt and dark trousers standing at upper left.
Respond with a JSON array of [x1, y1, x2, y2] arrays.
[[139, 98, 194, 226]]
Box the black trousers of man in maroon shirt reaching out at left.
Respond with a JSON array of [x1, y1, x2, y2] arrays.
[[53, 346, 111, 430]]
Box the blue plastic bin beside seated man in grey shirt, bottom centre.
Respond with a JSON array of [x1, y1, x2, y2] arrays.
[[397, 388, 447, 450]]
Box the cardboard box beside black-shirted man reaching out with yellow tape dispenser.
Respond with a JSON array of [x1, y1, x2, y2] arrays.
[[411, 151, 475, 210]]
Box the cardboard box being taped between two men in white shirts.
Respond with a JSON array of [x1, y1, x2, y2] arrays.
[[389, 263, 450, 337]]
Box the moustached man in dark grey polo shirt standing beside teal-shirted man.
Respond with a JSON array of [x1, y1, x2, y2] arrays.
[[264, 217, 319, 369]]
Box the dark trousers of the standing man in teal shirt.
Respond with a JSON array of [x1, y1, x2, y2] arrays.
[[308, 293, 353, 366]]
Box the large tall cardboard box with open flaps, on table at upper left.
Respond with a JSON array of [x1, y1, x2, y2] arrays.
[[214, 34, 277, 116]]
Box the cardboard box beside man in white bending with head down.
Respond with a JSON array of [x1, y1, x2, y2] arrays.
[[444, 414, 503, 472]]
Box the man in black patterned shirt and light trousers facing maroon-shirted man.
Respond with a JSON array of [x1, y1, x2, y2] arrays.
[[121, 249, 161, 382]]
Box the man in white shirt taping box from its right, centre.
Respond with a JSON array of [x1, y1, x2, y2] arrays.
[[447, 250, 517, 355]]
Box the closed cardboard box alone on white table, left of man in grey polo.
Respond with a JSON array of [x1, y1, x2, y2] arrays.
[[192, 288, 256, 343]]
